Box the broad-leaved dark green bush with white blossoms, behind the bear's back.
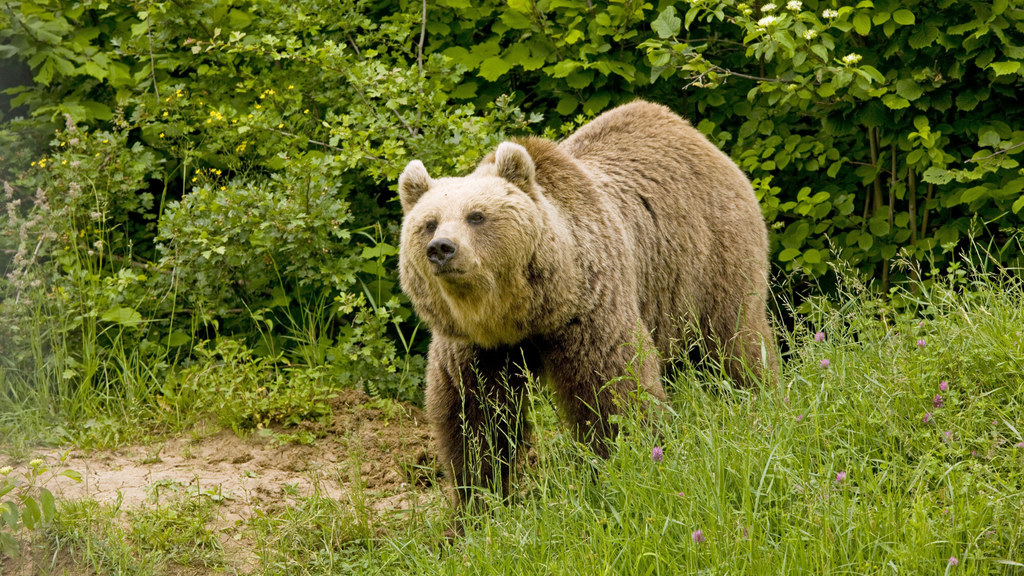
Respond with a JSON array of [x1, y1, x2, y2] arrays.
[[428, 0, 1024, 288]]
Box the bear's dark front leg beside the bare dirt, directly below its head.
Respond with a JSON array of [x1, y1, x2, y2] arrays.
[[426, 334, 529, 508]]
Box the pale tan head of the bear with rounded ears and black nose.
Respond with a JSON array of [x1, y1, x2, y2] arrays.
[[398, 142, 547, 347]]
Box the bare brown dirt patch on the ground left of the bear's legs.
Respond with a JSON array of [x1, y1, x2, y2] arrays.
[[0, 390, 436, 575]]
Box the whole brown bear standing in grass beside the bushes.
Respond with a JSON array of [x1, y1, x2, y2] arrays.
[[398, 101, 776, 504]]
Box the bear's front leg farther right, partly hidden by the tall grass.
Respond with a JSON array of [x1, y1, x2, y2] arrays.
[[542, 315, 666, 457]]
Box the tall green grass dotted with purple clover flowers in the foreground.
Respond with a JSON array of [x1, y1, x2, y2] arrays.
[[2, 276, 1024, 575]]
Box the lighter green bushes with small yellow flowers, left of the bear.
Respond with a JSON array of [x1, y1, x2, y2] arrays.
[[0, 0, 526, 422]]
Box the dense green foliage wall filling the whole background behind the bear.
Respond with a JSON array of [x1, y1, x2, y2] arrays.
[[0, 0, 1024, 428]]
